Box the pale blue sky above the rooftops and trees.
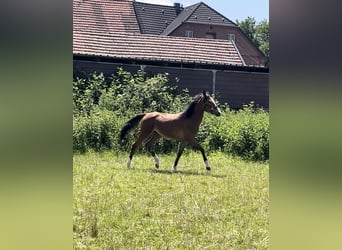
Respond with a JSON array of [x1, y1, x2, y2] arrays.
[[136, 0, 269, 22]]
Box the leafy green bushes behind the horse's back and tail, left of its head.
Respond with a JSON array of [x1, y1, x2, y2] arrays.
[[73, 68, 190, 153]]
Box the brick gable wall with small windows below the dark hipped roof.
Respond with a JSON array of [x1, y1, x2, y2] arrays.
[[170, 23, 265, 65]]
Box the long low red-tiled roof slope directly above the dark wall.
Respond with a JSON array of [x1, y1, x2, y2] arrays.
[[73, 29, 243, 65]]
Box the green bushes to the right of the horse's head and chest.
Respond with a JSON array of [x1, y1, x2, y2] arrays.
[[200, 103, 269, 161]]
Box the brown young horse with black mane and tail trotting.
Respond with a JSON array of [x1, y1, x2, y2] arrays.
[[120, 91, 221, 171]]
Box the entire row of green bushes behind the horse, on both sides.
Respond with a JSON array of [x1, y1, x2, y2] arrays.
[[73, 69, 269, 161]]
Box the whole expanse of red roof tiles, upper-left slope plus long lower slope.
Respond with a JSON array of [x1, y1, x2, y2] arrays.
[[73, 0, 244, 65]]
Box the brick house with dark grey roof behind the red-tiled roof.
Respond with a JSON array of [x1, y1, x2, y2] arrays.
[[133, 2, 265, 65]]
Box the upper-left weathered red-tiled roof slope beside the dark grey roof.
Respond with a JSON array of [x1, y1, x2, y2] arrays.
[[73, 0, 140, 33]]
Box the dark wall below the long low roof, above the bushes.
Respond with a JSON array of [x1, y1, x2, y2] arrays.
[[74, 60, 269, 109]]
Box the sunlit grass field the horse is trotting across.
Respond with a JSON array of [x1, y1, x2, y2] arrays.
[[73, 150, 269, 250]]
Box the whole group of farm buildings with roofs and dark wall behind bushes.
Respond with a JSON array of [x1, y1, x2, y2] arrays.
[[73, 0, 269, 108]]
